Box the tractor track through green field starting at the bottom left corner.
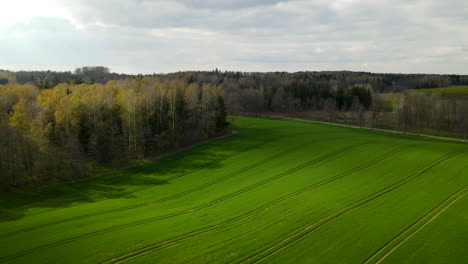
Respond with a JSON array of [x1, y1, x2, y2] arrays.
[[0, 142, 369, 263]]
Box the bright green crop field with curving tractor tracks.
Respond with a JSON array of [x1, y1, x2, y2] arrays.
[[0, 118, 468, 263]]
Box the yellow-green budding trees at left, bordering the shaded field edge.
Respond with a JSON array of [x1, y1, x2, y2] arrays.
[[0, 77, 227, 190]]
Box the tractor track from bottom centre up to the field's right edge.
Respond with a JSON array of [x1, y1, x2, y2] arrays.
[[240, 150, 466, 263]]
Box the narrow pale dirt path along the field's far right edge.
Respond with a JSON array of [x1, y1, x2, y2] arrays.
[[240, 113, 467, 143]]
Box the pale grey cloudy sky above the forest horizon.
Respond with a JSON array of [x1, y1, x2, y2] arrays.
[[0, 0, 468, 74]]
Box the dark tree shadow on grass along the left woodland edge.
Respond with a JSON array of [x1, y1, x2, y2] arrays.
[[0, 128, 271, 222]]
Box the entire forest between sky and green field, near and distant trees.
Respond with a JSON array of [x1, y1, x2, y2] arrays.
[[0, 66, 468, 191]]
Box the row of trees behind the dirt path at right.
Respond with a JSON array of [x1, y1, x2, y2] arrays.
[[226, 82, 468, 140]]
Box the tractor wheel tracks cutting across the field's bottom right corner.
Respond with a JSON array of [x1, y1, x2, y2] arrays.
[[364, 186, 468, 264]]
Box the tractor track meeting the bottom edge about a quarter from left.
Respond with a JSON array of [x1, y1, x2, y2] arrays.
[[104, 145, 410, 264]]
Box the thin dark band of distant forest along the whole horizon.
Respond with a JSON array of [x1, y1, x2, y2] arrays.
[[0, 66, 468, 92]]
